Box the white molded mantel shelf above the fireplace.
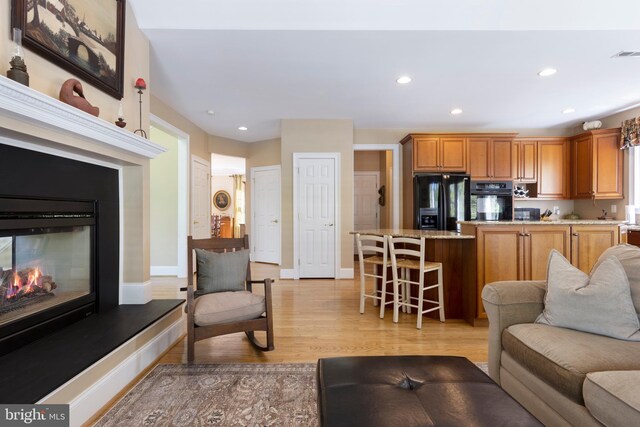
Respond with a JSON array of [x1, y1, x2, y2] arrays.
[[0, 76, 166, 159]]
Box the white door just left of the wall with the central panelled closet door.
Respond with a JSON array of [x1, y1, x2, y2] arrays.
[[251, 166, 281, 264]]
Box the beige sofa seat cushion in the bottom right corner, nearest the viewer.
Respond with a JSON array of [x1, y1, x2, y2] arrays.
[[582, 371, 640, 426]]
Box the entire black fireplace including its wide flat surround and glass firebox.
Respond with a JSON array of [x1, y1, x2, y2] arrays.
[[0, 145, 119, 356]]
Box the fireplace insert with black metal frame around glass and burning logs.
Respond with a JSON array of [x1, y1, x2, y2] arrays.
[[0, 198, 96, 354]]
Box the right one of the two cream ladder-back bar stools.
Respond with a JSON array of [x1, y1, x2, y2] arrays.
[[388, 236, 444, 329]]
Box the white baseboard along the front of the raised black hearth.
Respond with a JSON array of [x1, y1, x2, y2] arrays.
[[39, 308, 184, 427]]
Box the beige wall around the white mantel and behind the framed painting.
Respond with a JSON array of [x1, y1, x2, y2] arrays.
[[0, 1, 153, 283]]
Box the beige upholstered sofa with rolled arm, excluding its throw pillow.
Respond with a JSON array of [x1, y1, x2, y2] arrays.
[[482, 245, 640, 426]]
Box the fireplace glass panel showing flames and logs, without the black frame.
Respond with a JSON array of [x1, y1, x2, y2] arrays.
[[0, 226, 92, 326]]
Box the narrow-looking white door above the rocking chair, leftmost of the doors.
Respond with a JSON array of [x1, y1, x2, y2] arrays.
[[191, 156, 211, 239]]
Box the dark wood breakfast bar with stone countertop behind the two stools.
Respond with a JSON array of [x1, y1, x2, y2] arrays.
[[351, 229, 476, 324]]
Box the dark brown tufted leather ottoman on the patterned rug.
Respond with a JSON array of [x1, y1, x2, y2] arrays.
[[317, 356, 542, 427]]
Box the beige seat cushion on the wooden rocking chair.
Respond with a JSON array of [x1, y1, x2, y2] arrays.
[[194, 291, 266, 326]]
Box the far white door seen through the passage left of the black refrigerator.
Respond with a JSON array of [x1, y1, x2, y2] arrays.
[[353, 172, 380, 254]]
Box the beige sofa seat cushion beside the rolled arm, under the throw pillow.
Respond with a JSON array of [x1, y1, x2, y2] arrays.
[[502, 323, 640, 405]]
